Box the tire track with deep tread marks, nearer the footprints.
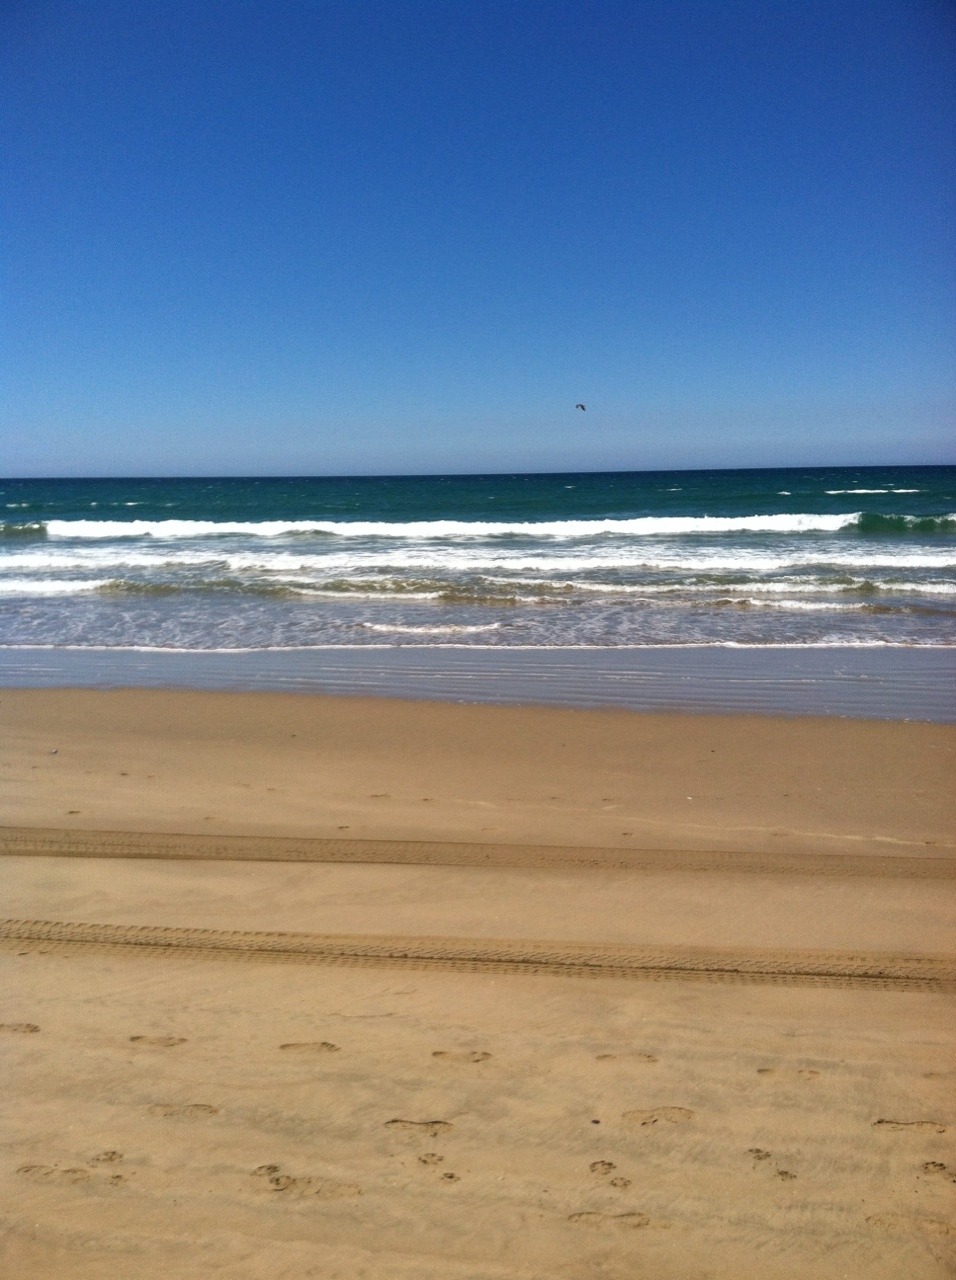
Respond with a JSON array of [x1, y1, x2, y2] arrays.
[[0, 920, 956, 991]]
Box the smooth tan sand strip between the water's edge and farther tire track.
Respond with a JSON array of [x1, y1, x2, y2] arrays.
[[0, 689, 956, 856]]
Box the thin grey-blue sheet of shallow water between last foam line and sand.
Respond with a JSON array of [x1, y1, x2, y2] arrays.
[[0, 645, 956, 723]]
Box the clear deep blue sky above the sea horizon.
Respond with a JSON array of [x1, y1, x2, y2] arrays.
[[0, 0, 956, 476]]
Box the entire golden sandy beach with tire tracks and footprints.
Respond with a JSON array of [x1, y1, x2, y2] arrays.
[[0, 690, 956, 1280]]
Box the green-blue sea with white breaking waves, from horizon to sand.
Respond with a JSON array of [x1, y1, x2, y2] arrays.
[[0, 466, 956, 719]]
